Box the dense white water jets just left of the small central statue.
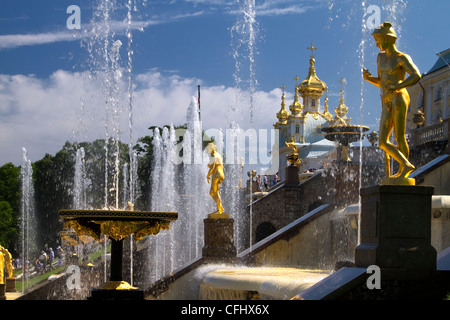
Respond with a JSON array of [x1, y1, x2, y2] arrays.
[[148, 98, 212, 282]]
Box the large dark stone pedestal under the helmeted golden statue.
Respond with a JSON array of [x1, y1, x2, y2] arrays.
[[355, 185, 437, 271]]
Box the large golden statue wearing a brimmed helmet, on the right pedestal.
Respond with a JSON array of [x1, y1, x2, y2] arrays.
[[363, 22, 421, 185]]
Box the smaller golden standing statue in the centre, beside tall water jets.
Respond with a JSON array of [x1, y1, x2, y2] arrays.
[[206, 143, 225, 214]]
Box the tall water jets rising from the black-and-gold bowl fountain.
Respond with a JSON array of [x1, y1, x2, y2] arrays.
[[75, 0, 146, 284]]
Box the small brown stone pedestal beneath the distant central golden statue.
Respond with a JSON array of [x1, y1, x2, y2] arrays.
[[202, 213, 236, 261]]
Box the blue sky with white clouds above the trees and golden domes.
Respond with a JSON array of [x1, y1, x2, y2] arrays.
[[0, 0, 450, 164]]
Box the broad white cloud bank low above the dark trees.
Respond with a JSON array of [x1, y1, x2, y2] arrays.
[[0, 70, 281, 165]]
